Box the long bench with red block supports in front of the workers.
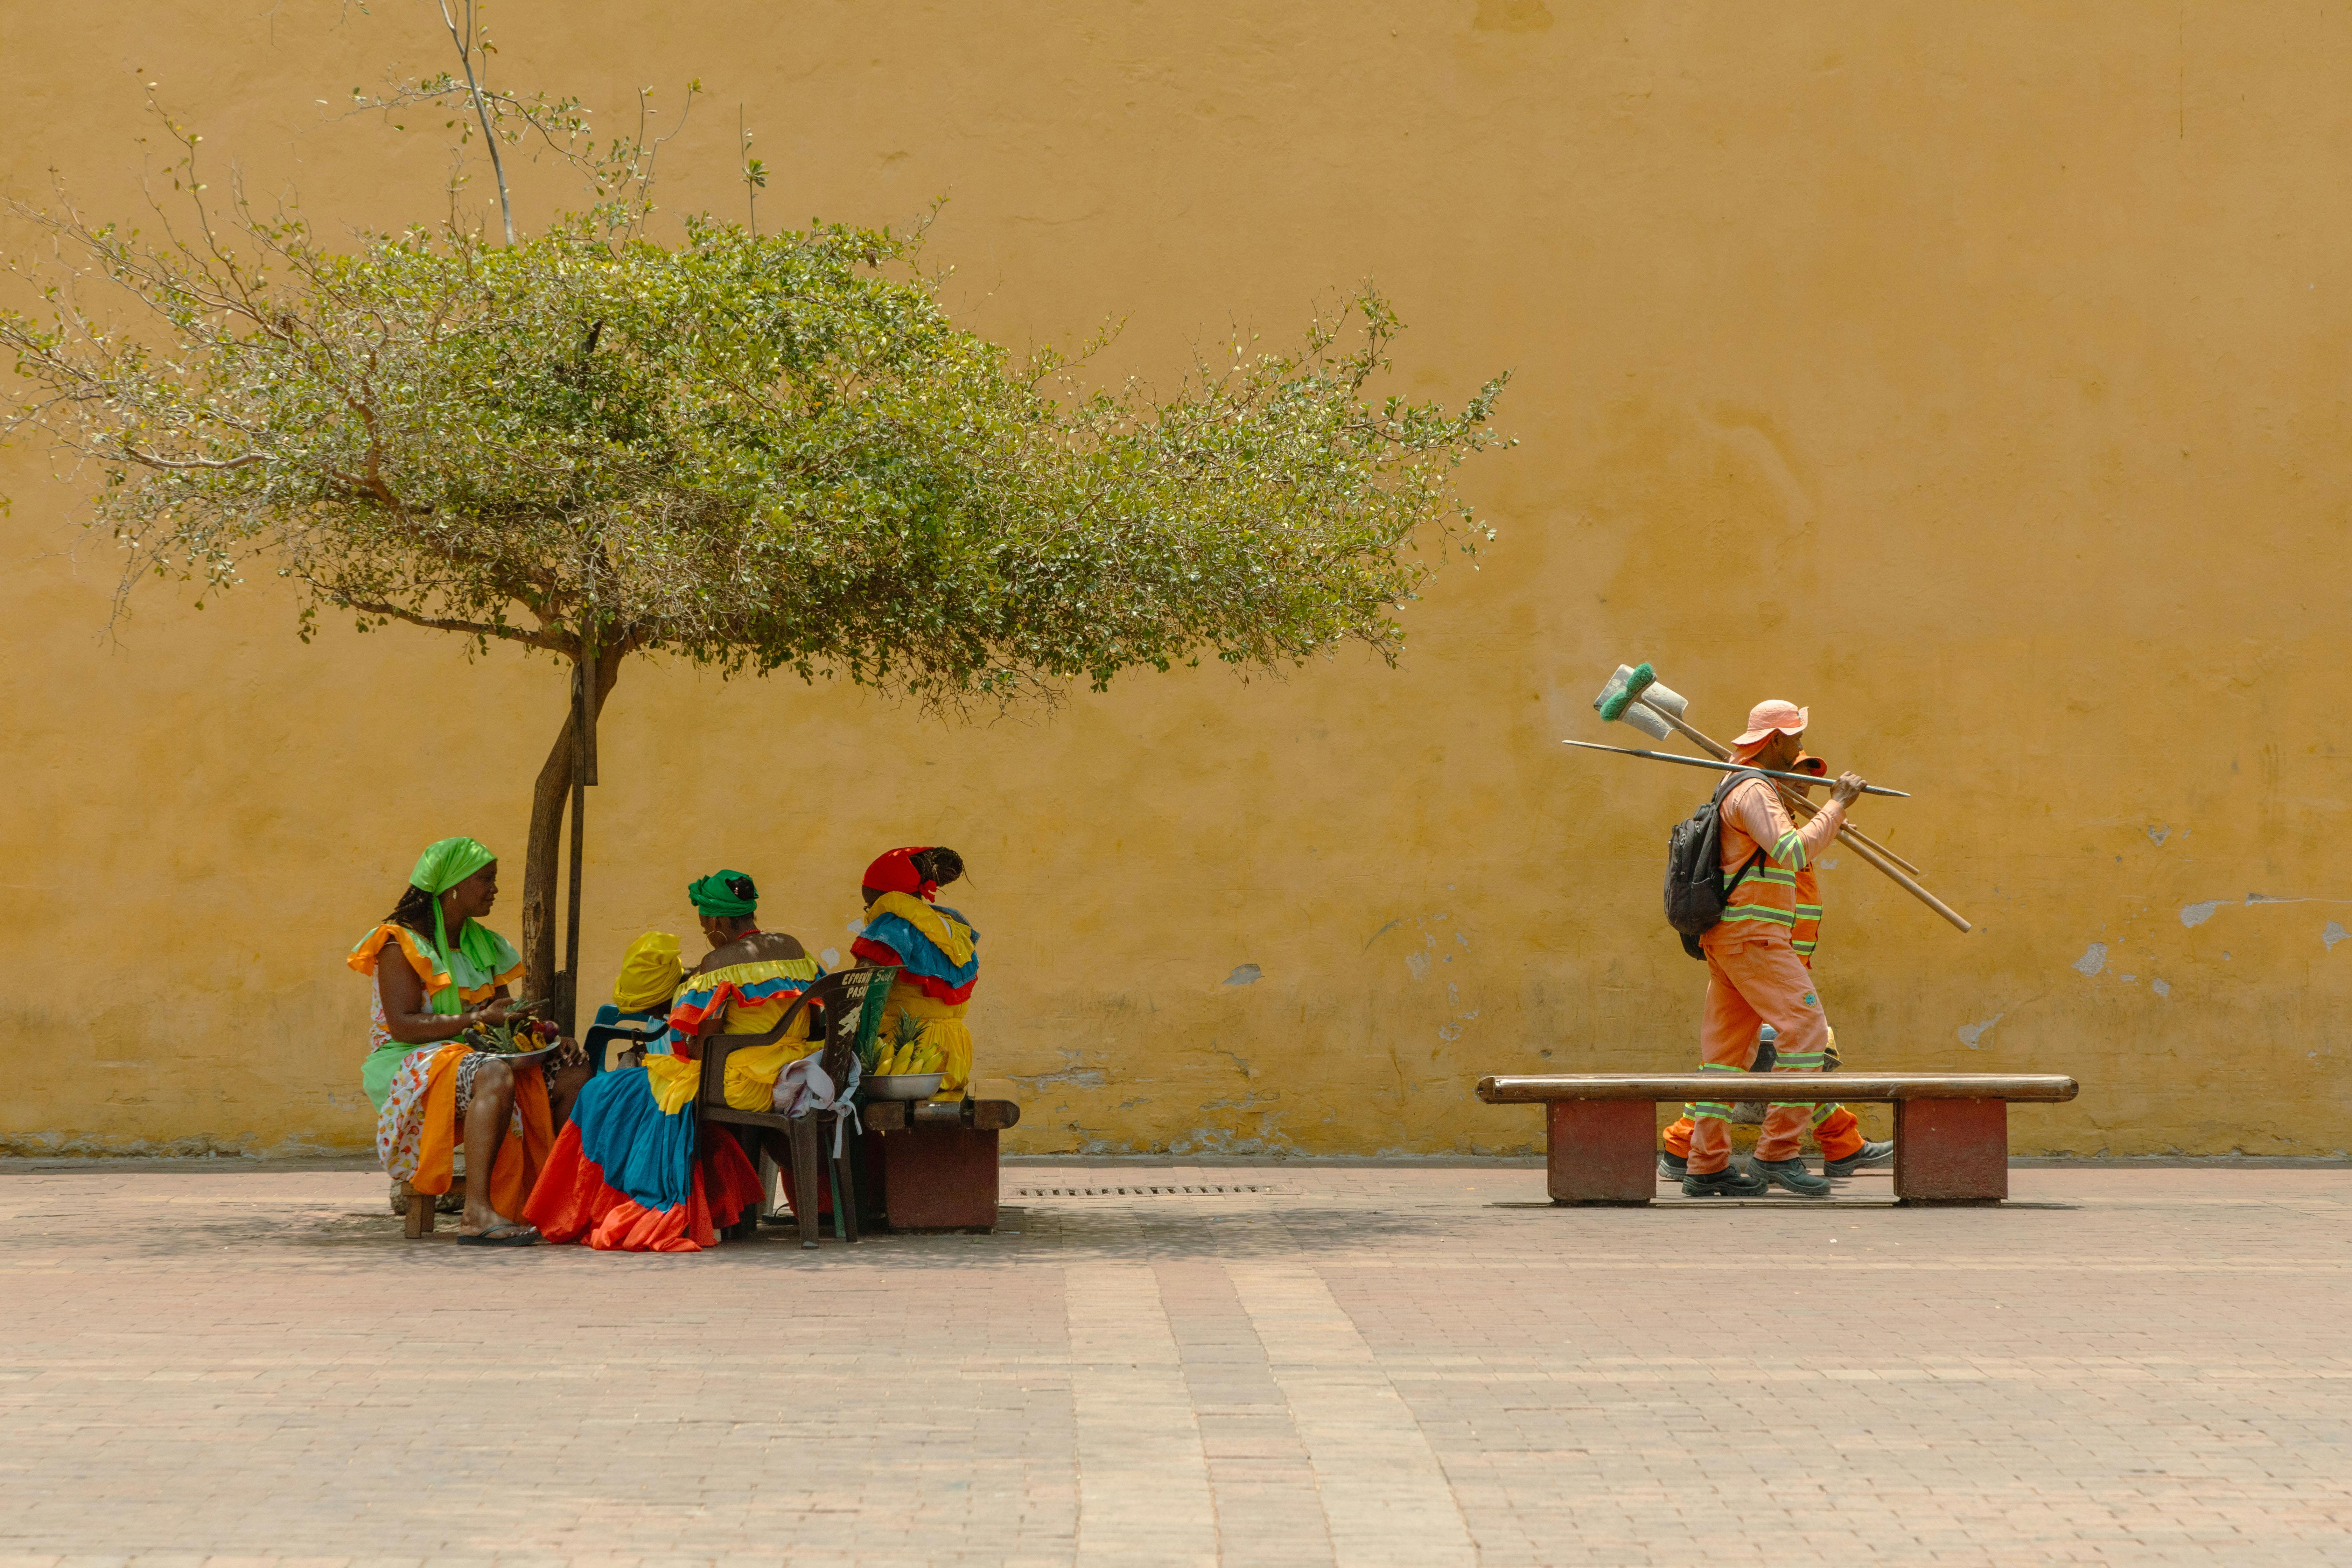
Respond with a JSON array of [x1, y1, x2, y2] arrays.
[[1477, 1072, 2079, 1204]]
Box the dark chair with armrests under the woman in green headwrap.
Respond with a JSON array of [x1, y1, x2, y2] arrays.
[[685, 964, 898, 1246]]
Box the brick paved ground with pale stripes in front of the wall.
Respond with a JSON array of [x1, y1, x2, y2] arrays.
[[0, 1164, 2352, 1568]]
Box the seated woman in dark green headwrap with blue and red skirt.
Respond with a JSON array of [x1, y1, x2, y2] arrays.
[[522, 872, 826, 1253]]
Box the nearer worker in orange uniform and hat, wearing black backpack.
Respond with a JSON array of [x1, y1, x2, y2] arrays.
[[1682, 698, 1863, 1197]]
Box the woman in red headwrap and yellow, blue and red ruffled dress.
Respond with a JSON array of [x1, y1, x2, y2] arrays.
[[849, 846, 981, 1100]]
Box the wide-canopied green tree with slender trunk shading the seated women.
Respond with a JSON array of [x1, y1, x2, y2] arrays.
[[0, 27, 1503, 1029]]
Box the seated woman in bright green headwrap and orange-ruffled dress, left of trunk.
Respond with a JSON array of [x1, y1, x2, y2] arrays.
[[346, 839, 588, 1246]]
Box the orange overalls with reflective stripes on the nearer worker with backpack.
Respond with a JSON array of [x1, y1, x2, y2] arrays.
[[1689, 778, 1846, 1175]]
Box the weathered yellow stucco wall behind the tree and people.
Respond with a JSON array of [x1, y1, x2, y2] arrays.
[[0, 0, 2352, 1154]]
